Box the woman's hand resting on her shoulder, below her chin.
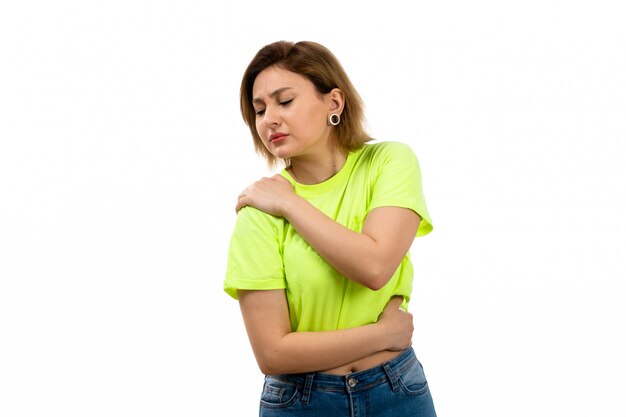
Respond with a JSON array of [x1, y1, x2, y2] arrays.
[[235, 174, 296, 217]]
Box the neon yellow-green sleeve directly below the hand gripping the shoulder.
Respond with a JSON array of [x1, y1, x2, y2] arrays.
[[224, 207, 287, 299]]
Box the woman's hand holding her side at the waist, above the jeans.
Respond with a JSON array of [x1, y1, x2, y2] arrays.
[[378, 297, 413, 351]]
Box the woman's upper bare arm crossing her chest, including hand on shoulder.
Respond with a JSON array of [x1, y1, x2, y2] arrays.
[[236, 175, 420, 290]]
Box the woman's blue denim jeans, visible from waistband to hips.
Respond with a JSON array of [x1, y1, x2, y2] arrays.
[[259, 348, 436, 417]]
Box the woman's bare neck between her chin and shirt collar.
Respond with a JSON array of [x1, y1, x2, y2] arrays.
[[288, 149, 346, 185]]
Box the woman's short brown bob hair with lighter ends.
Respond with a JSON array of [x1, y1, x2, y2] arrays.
[[240, 41, 372, 166]]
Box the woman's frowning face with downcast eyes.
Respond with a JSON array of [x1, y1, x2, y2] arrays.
[[252, 66, 333, 160]]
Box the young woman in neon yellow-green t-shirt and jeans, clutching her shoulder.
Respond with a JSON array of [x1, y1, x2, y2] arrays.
[[224, 41, 435, 417]]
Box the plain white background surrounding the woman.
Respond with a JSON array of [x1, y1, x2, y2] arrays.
[[0, 0, 626, 417]]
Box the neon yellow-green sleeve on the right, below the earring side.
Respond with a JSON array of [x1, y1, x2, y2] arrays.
[[369, 142, 433, 236]]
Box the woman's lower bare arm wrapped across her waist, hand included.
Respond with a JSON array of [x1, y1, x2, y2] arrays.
[[238, 290, 413, 375]]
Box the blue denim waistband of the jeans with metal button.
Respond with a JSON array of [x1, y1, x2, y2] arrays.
[[266, 348, 417, 397]]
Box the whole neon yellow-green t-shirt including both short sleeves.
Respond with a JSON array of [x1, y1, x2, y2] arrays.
[[224, 142, 432, 331]]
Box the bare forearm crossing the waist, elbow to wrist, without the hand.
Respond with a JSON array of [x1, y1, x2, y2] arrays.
[[257, 324, 386, 375]]
